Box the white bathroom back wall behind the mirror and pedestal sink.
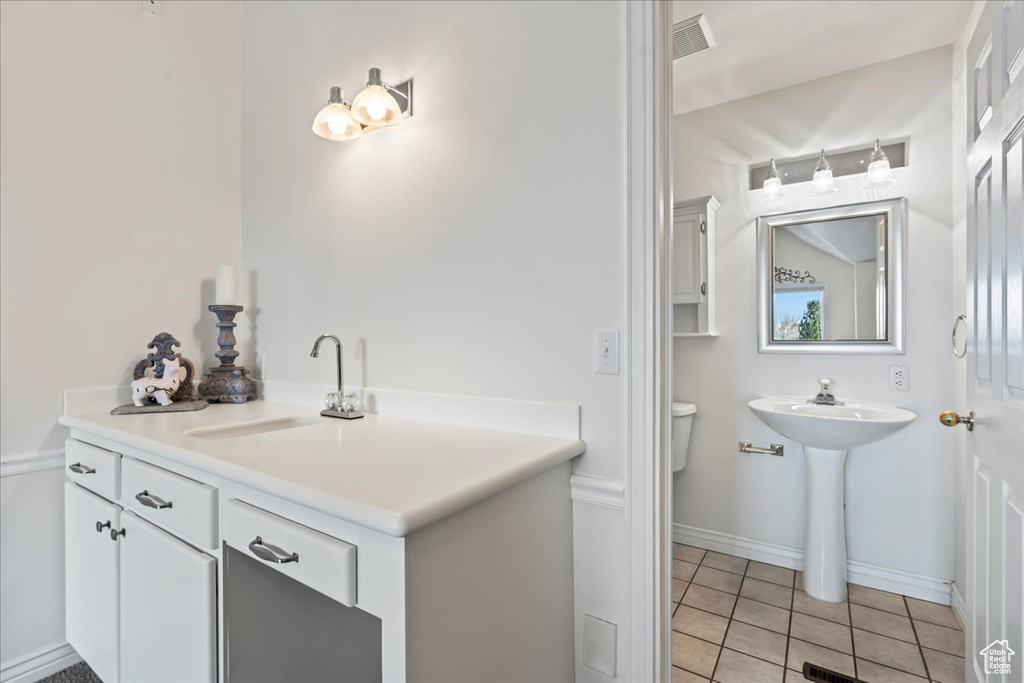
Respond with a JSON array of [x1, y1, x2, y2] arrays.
[[675, 47, 958, 580]]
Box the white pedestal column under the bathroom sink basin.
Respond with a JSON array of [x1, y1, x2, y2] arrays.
[[804, 446, 847, 602]]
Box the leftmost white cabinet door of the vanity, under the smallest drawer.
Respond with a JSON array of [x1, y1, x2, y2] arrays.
[[65, 481, 121, 683]]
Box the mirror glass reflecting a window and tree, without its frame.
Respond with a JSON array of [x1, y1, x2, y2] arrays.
[[771, 213, 887, 341]]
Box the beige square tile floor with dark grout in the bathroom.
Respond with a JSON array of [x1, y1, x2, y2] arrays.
[[672, 543, 965, 683]]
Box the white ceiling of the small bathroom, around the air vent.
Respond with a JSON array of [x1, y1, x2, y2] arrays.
[[673, 0, 973, 114]]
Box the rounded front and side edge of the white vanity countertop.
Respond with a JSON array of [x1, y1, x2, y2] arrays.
[[58, 415, 586, 538]]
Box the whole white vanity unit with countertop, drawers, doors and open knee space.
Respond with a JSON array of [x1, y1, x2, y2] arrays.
[[61, 401, 583, 683]]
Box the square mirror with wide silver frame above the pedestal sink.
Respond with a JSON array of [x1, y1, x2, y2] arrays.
[[757, 198, 906, 354]]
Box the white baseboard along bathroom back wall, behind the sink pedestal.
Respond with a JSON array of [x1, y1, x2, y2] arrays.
[[673, 523, 951, 605]]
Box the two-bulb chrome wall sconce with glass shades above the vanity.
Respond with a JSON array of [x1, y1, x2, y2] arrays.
[[313, 69, 413, 141]]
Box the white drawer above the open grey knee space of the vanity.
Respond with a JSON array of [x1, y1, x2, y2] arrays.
[[224, 499, 356, 607]]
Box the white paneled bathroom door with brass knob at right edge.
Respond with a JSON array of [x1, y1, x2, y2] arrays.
[[967, 1, 1024, 682]]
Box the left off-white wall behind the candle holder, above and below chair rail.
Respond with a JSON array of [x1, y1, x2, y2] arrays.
[[0, 0, 241, 675]]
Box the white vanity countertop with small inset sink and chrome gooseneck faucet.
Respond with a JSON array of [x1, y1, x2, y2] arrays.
[[60, 400, 586, 537]]
